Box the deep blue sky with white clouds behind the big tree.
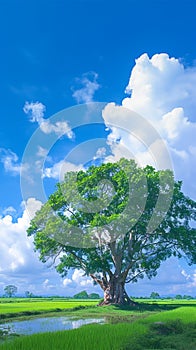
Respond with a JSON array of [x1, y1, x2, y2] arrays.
[[0, 0, 196, 296]]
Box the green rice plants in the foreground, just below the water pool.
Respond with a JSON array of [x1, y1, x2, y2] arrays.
[[0, 323, 146, 350]]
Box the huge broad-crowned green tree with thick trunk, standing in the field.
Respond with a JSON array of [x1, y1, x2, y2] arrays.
[[27, 159, 196, 304]]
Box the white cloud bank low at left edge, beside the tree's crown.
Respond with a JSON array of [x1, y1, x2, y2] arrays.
[[0, 198, 63, 295]]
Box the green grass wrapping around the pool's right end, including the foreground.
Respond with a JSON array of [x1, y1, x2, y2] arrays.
[[0, 300, 196, 350]]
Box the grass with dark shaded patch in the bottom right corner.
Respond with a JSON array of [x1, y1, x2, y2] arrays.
[[124, 306, 196, 350]]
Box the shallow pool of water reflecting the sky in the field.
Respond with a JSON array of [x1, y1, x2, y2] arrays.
[[0, 316, 105, 335]]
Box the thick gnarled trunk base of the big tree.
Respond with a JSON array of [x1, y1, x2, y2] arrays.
[[99, 276, 135, 305]]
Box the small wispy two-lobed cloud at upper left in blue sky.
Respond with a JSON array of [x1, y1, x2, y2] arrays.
[[23, 102, 74, 139]]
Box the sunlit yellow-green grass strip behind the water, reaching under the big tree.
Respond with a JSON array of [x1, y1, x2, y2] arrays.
[[0, 298, 173, 321]]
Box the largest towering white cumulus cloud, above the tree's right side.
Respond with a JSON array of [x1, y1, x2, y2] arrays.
[[103, 53, 196, 197]]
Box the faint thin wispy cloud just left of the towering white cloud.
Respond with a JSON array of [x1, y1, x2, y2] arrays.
[[72, 72, 100, 103]]
